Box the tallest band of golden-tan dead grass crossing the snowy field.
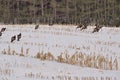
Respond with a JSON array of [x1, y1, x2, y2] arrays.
[[2, 46, 118, 70]]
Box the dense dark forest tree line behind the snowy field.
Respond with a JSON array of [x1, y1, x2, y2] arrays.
[[0, 0, 120, 26]]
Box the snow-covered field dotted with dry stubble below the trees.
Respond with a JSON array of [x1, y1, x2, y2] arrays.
[[0, 25, 120, 80]]
